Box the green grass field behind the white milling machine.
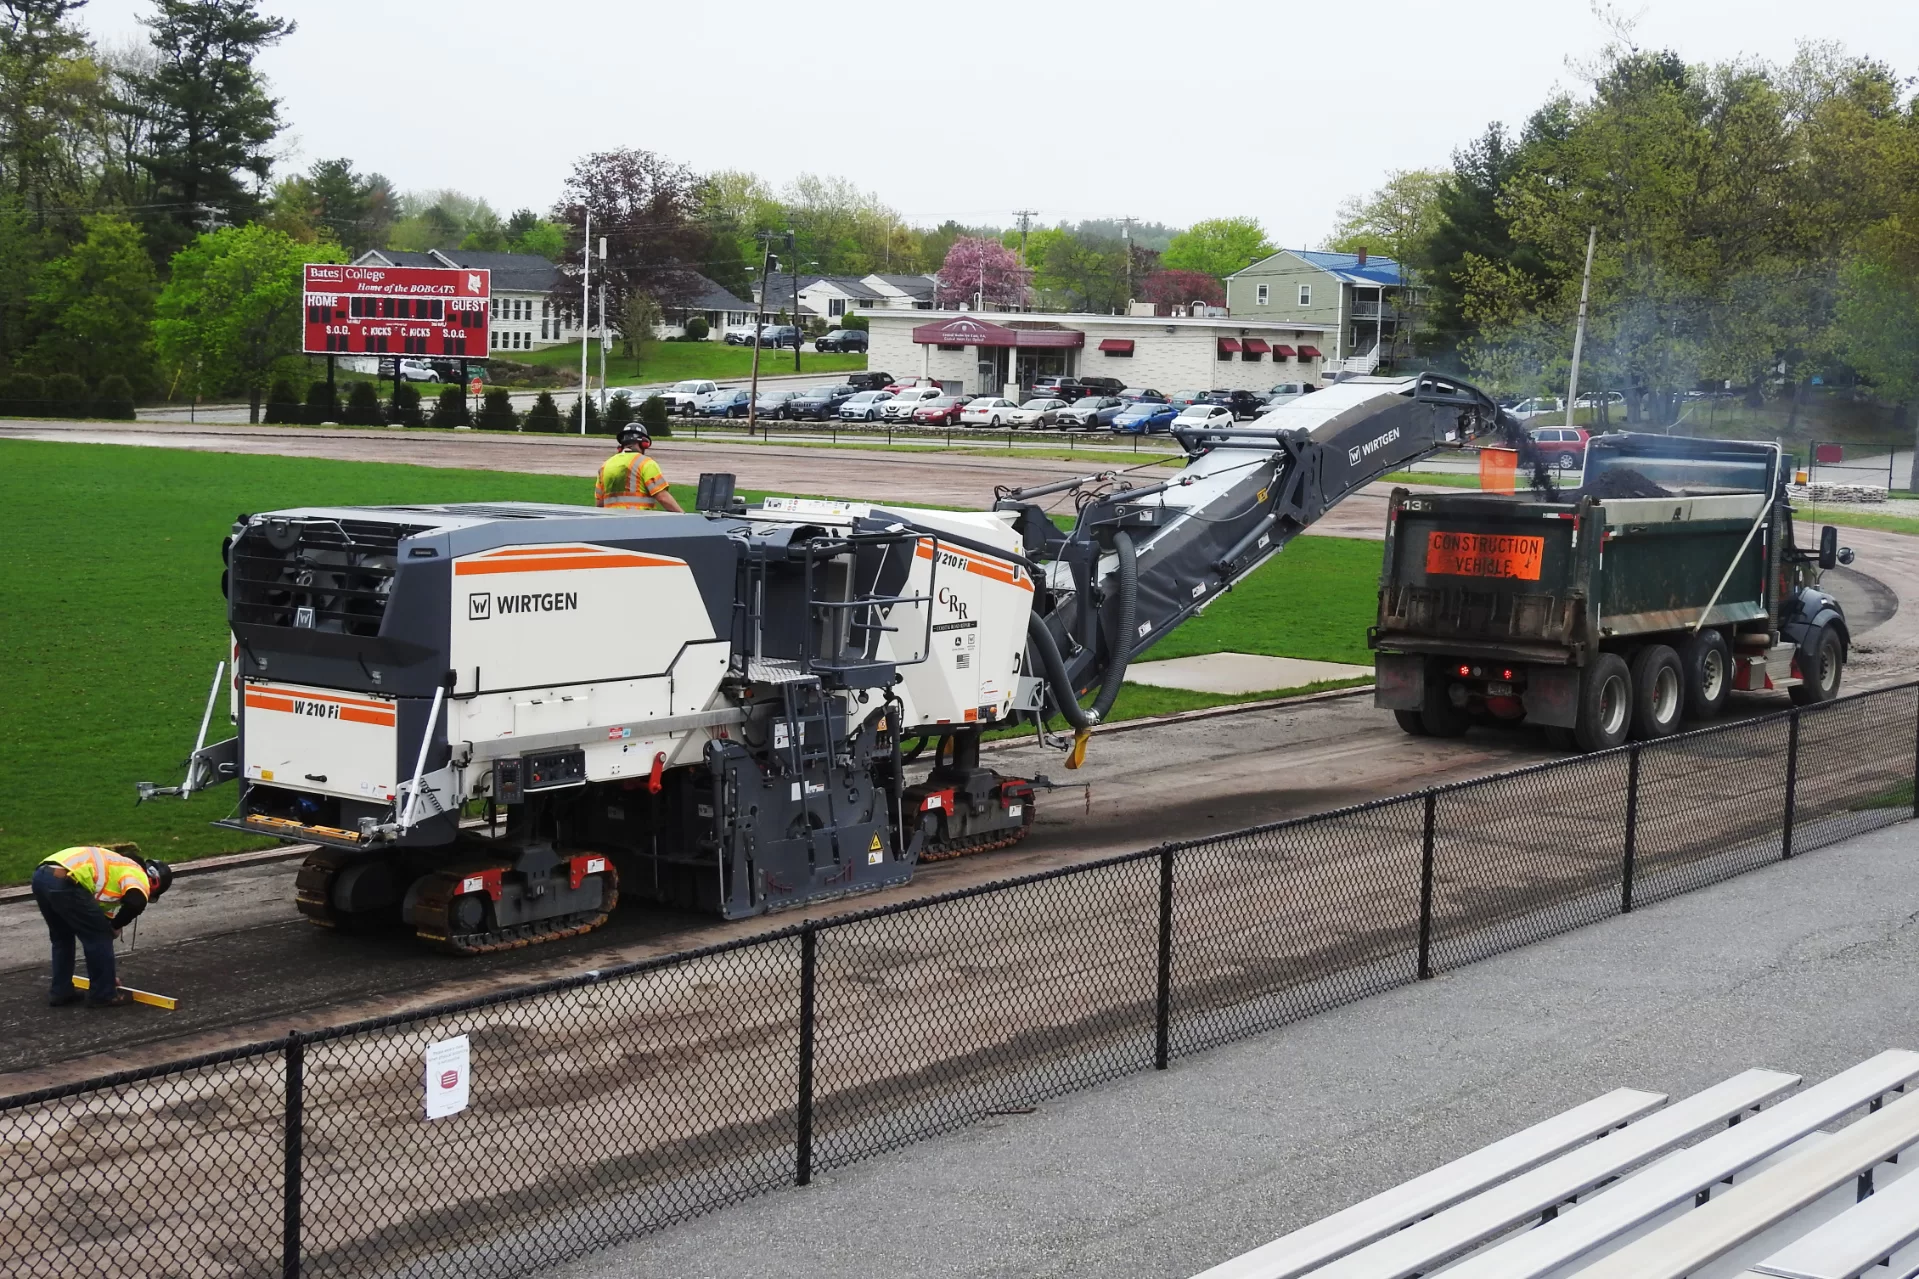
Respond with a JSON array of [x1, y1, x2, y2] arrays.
[[0, 440, 1380, 881]]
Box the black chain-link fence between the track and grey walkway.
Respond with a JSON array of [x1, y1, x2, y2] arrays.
[[0, 686, 1919, 1279]]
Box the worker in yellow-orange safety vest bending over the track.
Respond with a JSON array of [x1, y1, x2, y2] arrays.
[[33, 843, 173, 1008]]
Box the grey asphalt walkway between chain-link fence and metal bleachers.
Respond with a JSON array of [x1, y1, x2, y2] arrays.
[[541, 822, 1919, 1279]]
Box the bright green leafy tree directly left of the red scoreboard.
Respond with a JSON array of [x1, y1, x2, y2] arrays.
[[154, 225, 345, 422]]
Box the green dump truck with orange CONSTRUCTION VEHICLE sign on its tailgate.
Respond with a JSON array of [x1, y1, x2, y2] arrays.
[[1368, 434, 1852, 751]]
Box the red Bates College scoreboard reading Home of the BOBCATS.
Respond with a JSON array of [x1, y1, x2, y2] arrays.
[[305, 263, 493, 359]]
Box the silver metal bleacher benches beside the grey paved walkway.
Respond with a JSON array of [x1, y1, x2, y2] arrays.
[[1199, 1050, 1919, 1279]]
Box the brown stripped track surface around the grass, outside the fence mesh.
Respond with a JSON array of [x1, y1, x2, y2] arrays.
[[0, 426, 1919, 1093]]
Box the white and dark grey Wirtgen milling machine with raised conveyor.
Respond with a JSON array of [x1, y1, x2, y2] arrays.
[[142, 374, 1522, 953]]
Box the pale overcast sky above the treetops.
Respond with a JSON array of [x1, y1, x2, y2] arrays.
[[83, 0, 1919, 248]]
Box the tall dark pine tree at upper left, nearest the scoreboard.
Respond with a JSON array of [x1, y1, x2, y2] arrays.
[[138, 0, 296, 255]]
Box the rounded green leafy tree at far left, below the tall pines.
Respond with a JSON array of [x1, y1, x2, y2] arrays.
[[27, 213, 159, 386]]
